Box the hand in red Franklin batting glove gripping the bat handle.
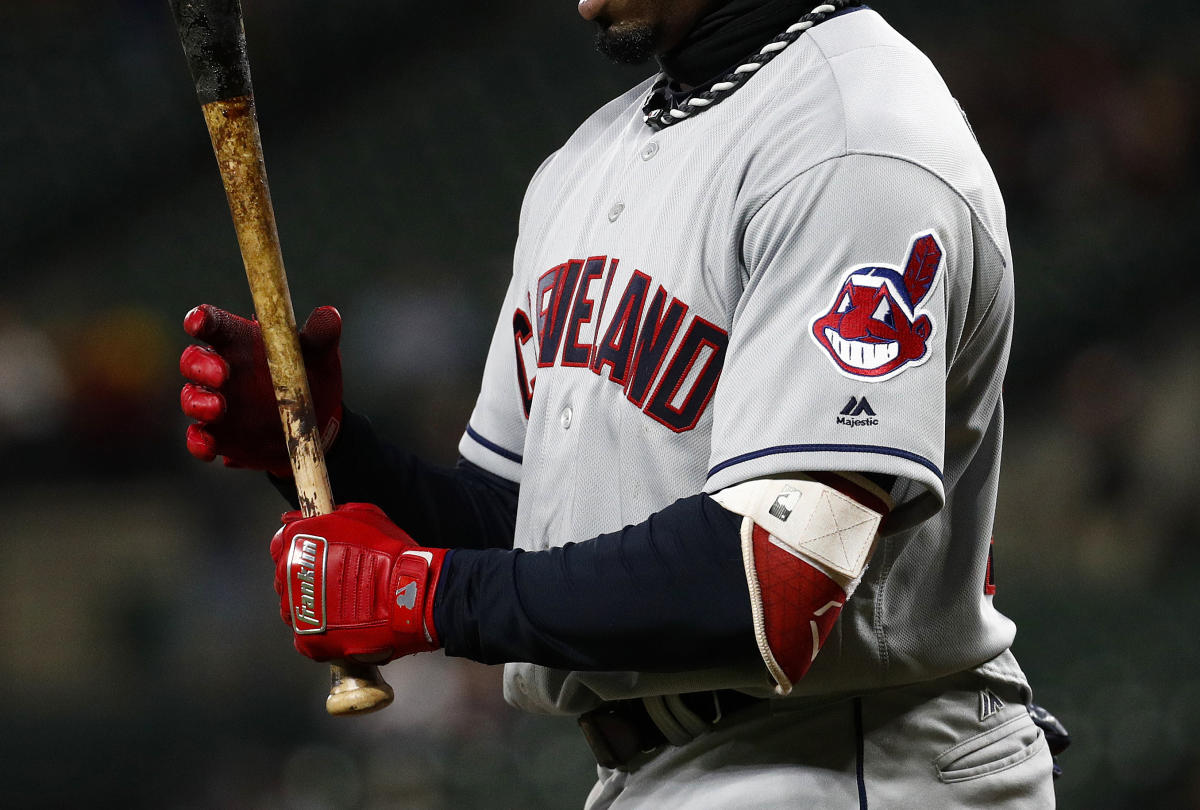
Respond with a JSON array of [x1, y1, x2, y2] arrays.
[[271, 504, 446, 664]]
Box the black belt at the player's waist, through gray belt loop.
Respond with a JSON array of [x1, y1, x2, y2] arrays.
[[580, 689, 766, 768]]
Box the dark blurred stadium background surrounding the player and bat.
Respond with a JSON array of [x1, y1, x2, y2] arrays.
[[0, 0, 1200, 808]]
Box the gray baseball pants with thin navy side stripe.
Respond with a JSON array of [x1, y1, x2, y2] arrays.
[[587, 673, 1055, 810]]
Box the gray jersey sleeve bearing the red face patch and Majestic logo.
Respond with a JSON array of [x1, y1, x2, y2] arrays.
[[706, 155, 973, 502]]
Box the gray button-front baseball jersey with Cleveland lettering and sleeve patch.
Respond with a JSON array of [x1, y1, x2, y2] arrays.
[[460, 10, 1025, 714]]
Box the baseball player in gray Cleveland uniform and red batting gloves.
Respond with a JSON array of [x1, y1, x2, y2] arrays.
[[181, 0, 1054, 809]]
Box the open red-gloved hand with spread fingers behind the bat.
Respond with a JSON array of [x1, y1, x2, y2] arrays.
[[179, 304, 342, 478]]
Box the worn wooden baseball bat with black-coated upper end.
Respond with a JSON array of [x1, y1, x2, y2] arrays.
[[169, 0, 392, 715]]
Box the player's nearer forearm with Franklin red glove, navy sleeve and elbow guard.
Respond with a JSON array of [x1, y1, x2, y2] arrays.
[[271, 473, 892, 695]]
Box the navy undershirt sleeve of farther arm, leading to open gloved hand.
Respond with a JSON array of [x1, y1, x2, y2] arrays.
[[269, 409, 520, 548]]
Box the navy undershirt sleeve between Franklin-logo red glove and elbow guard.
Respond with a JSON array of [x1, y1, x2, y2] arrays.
[[433, 494, 758, 672]]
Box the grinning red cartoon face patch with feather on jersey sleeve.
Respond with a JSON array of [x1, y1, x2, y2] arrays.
[[811, 233, 942, 380]]
